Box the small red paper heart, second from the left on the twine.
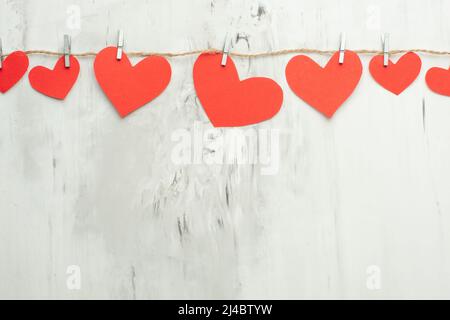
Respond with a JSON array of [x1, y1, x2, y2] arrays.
[[28, 56, 80, 100]]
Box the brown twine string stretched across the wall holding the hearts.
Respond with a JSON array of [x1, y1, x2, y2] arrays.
[[3, 48, 450, 58]]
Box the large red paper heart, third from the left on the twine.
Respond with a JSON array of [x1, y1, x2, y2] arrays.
[[94, 47, 172, 117]]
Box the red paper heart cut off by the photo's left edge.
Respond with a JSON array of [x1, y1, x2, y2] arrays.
[[0, 51, 28, 93]]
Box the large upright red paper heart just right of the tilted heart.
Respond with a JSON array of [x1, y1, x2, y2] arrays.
[[286, 50, 362, 118]]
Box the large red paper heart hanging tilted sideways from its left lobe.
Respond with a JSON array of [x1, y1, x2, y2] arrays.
[[194, 53, 283, 127]]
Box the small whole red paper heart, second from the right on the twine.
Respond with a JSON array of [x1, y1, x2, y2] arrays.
[[369, 52, 422, 95]]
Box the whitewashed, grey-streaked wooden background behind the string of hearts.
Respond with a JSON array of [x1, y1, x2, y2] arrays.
[[0, 0, 450, 299]]
